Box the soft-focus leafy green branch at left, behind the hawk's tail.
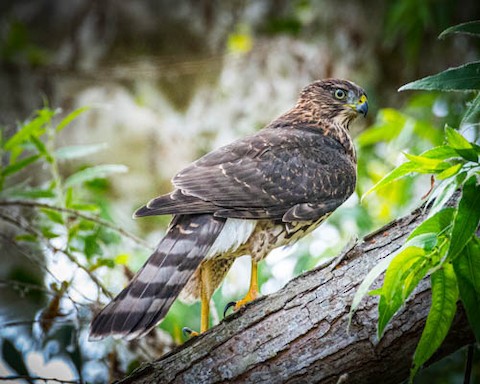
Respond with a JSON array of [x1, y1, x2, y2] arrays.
[[0, 107, 131, 294]]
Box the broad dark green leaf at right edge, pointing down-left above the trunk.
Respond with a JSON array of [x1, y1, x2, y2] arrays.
[[447, 176, 480, 260]]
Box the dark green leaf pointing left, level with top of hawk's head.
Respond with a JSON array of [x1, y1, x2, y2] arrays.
[[398, 61, 480, 92]]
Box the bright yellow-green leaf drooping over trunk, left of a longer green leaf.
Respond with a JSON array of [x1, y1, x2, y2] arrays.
[[378, 247, 426, 338]]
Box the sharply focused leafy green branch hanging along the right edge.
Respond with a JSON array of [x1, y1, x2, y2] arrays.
[[350, 21, 480, 381]]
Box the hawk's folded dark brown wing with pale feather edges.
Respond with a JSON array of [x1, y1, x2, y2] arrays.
[[136, 128, 356, 221]]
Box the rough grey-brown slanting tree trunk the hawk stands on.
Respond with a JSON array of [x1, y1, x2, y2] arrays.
[[121, 200, 474, 383]]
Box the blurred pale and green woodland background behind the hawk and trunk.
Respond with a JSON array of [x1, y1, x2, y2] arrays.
[[0, 0, 480, 383]]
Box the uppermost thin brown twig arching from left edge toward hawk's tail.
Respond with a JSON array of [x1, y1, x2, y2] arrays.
[[0, 200, 153, 250]]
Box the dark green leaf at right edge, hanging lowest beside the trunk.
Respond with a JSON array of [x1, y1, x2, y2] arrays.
[[453, 237, 480, 342]]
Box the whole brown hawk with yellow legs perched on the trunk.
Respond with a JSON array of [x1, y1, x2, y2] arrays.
[[90, 79, 368, 339]]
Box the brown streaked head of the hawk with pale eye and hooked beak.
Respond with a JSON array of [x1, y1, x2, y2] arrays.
[[298, 79, 368, 126]]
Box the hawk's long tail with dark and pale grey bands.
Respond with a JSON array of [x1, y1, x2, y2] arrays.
[[90, 214, 225, 340]]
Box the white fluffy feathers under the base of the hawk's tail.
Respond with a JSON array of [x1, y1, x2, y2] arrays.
[[205, 219, 257, 259]]
